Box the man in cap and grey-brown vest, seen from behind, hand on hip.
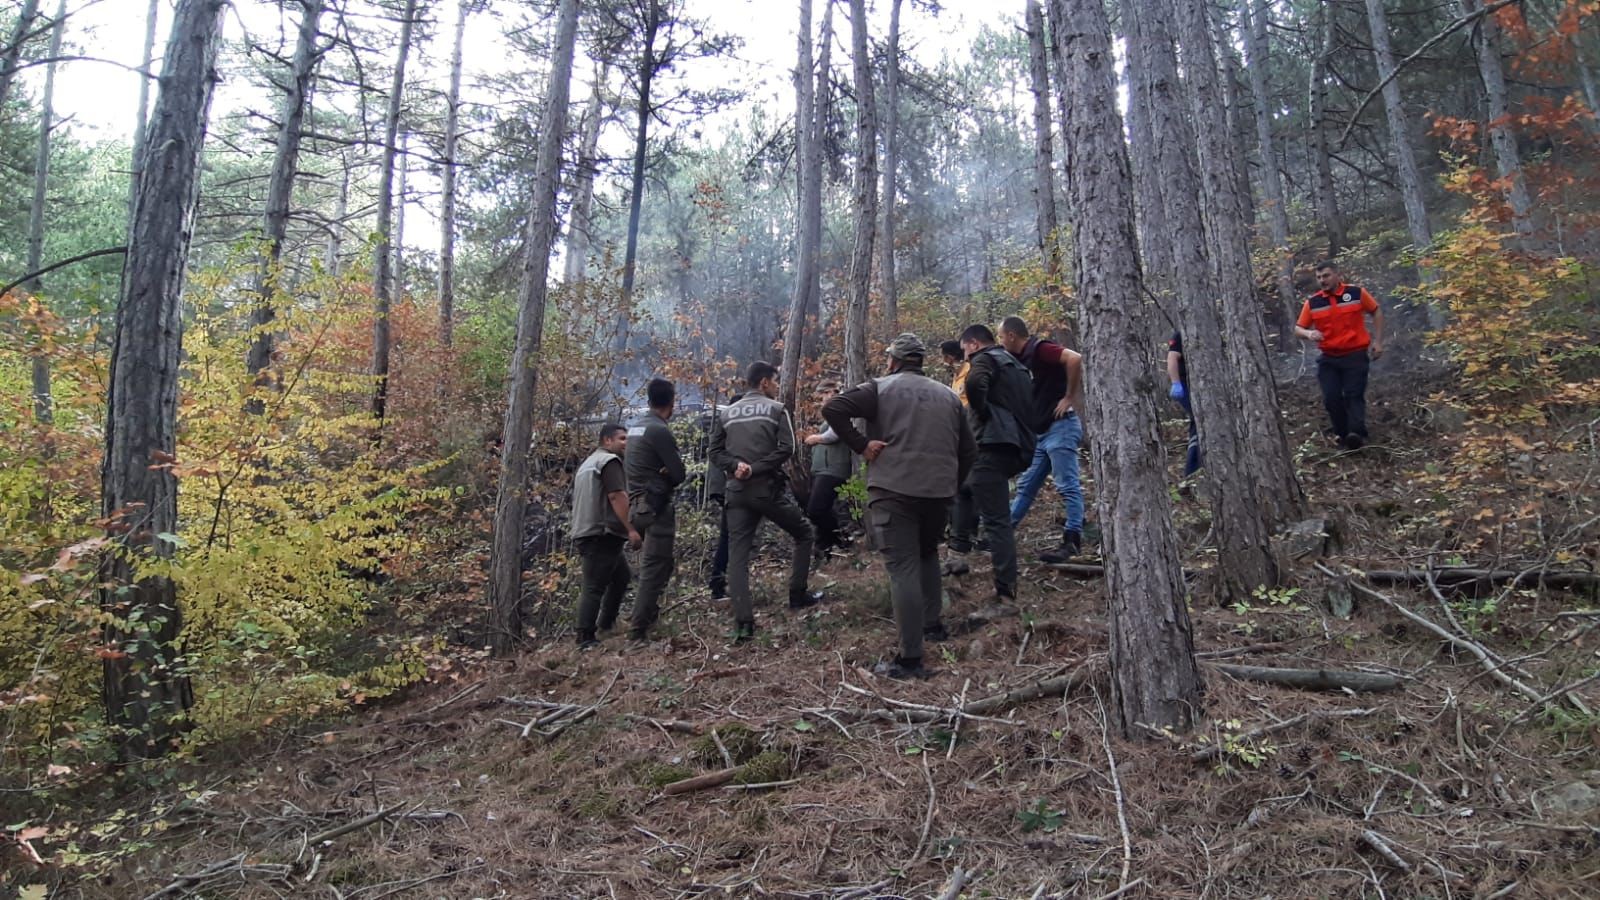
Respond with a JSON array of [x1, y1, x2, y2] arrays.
[[822, 331, 978, 679]]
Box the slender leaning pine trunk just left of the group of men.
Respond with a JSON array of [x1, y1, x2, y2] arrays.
[[488, 0, 578, 657]]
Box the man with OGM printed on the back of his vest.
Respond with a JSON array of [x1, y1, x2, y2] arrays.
[[710, 362, 818, 642]]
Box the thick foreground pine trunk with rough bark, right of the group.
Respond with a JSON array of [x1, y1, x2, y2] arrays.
[[1051, 0, 1200, 738]]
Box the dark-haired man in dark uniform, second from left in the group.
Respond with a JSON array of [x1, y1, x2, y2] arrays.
[[624, 378, 685, 641]]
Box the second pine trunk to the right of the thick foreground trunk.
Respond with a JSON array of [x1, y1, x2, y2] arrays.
[[1171, 0, 1304, 525]]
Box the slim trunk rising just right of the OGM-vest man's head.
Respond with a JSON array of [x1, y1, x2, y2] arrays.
[[779, 0, 832, 413]]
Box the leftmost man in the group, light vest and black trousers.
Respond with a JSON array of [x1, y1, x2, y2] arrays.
[[573, 423, 643, 650]]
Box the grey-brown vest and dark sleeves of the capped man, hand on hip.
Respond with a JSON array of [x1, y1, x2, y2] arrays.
[[822, 367, 978, 498]]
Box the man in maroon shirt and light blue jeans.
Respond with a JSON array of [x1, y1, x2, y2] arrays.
[[1000, 315, 1083, 564]]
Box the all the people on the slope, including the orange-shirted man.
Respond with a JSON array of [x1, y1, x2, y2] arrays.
[[573, 263, 1382, 677]]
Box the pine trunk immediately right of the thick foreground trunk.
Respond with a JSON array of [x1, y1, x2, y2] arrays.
[[1123, 0, 1278, 602]]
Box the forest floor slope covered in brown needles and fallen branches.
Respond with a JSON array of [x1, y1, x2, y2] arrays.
[[8, 339, 1600, 900]]
